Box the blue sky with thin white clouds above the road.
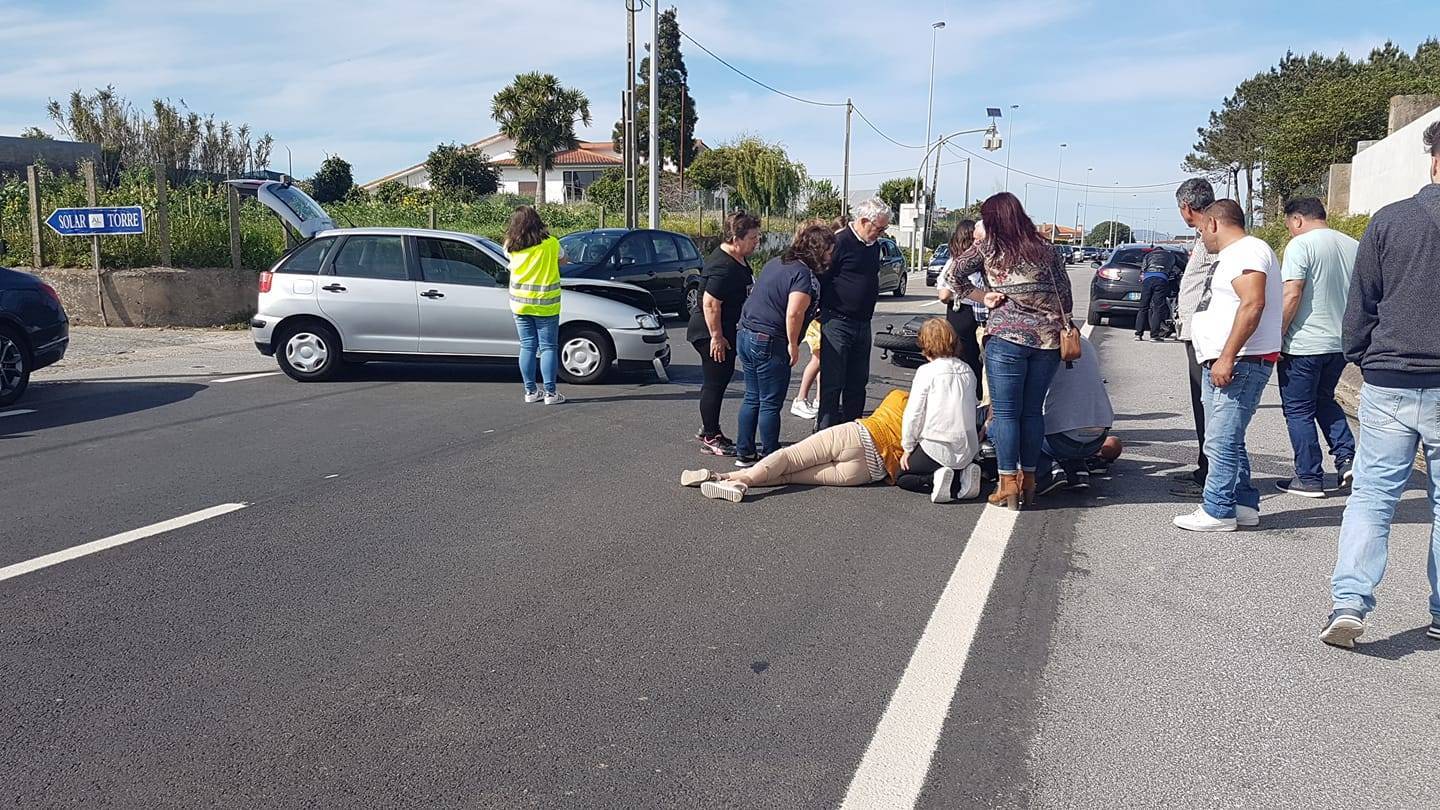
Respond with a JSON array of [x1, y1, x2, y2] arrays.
[[0, 0, 1440, 231]]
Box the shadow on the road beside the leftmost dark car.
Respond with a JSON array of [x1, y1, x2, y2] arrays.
[[0, 382, 206, 440]]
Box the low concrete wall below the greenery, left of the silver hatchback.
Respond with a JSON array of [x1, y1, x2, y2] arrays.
[[30, 267, 258, 326]]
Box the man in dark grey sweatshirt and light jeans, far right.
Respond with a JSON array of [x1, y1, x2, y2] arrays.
[[1320, 121, 1440, 647]]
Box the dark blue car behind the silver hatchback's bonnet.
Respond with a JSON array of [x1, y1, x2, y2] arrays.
[[560, 228, 704, 317]]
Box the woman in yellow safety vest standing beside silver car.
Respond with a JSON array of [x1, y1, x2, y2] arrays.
[[505, 205, 566, 405]]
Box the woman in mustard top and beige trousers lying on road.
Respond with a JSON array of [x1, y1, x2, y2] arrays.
[[680, 389, 910, 503]]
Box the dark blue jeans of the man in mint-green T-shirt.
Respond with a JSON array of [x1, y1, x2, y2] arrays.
[[1279, 353, 1355, 486]]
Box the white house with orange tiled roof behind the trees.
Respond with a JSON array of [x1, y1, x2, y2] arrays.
[[361, 134, 625, 202]]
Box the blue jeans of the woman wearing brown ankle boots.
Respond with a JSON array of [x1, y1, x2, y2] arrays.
[[984, 337, 1060, 474]]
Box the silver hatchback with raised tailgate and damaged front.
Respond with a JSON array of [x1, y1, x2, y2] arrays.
[[229, 180, 670, 385]]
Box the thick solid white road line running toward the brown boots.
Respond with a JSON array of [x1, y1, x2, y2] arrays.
[[841, 506, 1017, 810]]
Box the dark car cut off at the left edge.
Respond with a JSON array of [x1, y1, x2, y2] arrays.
[[0, 257, 71, 408]]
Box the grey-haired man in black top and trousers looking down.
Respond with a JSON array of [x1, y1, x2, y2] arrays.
[[815, 199, 890, 430]]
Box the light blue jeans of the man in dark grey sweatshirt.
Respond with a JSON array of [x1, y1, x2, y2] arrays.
[[1331, 383, 1440, 618]]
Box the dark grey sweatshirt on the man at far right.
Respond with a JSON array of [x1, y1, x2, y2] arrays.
[[1342, 183, 1440, 388]]
